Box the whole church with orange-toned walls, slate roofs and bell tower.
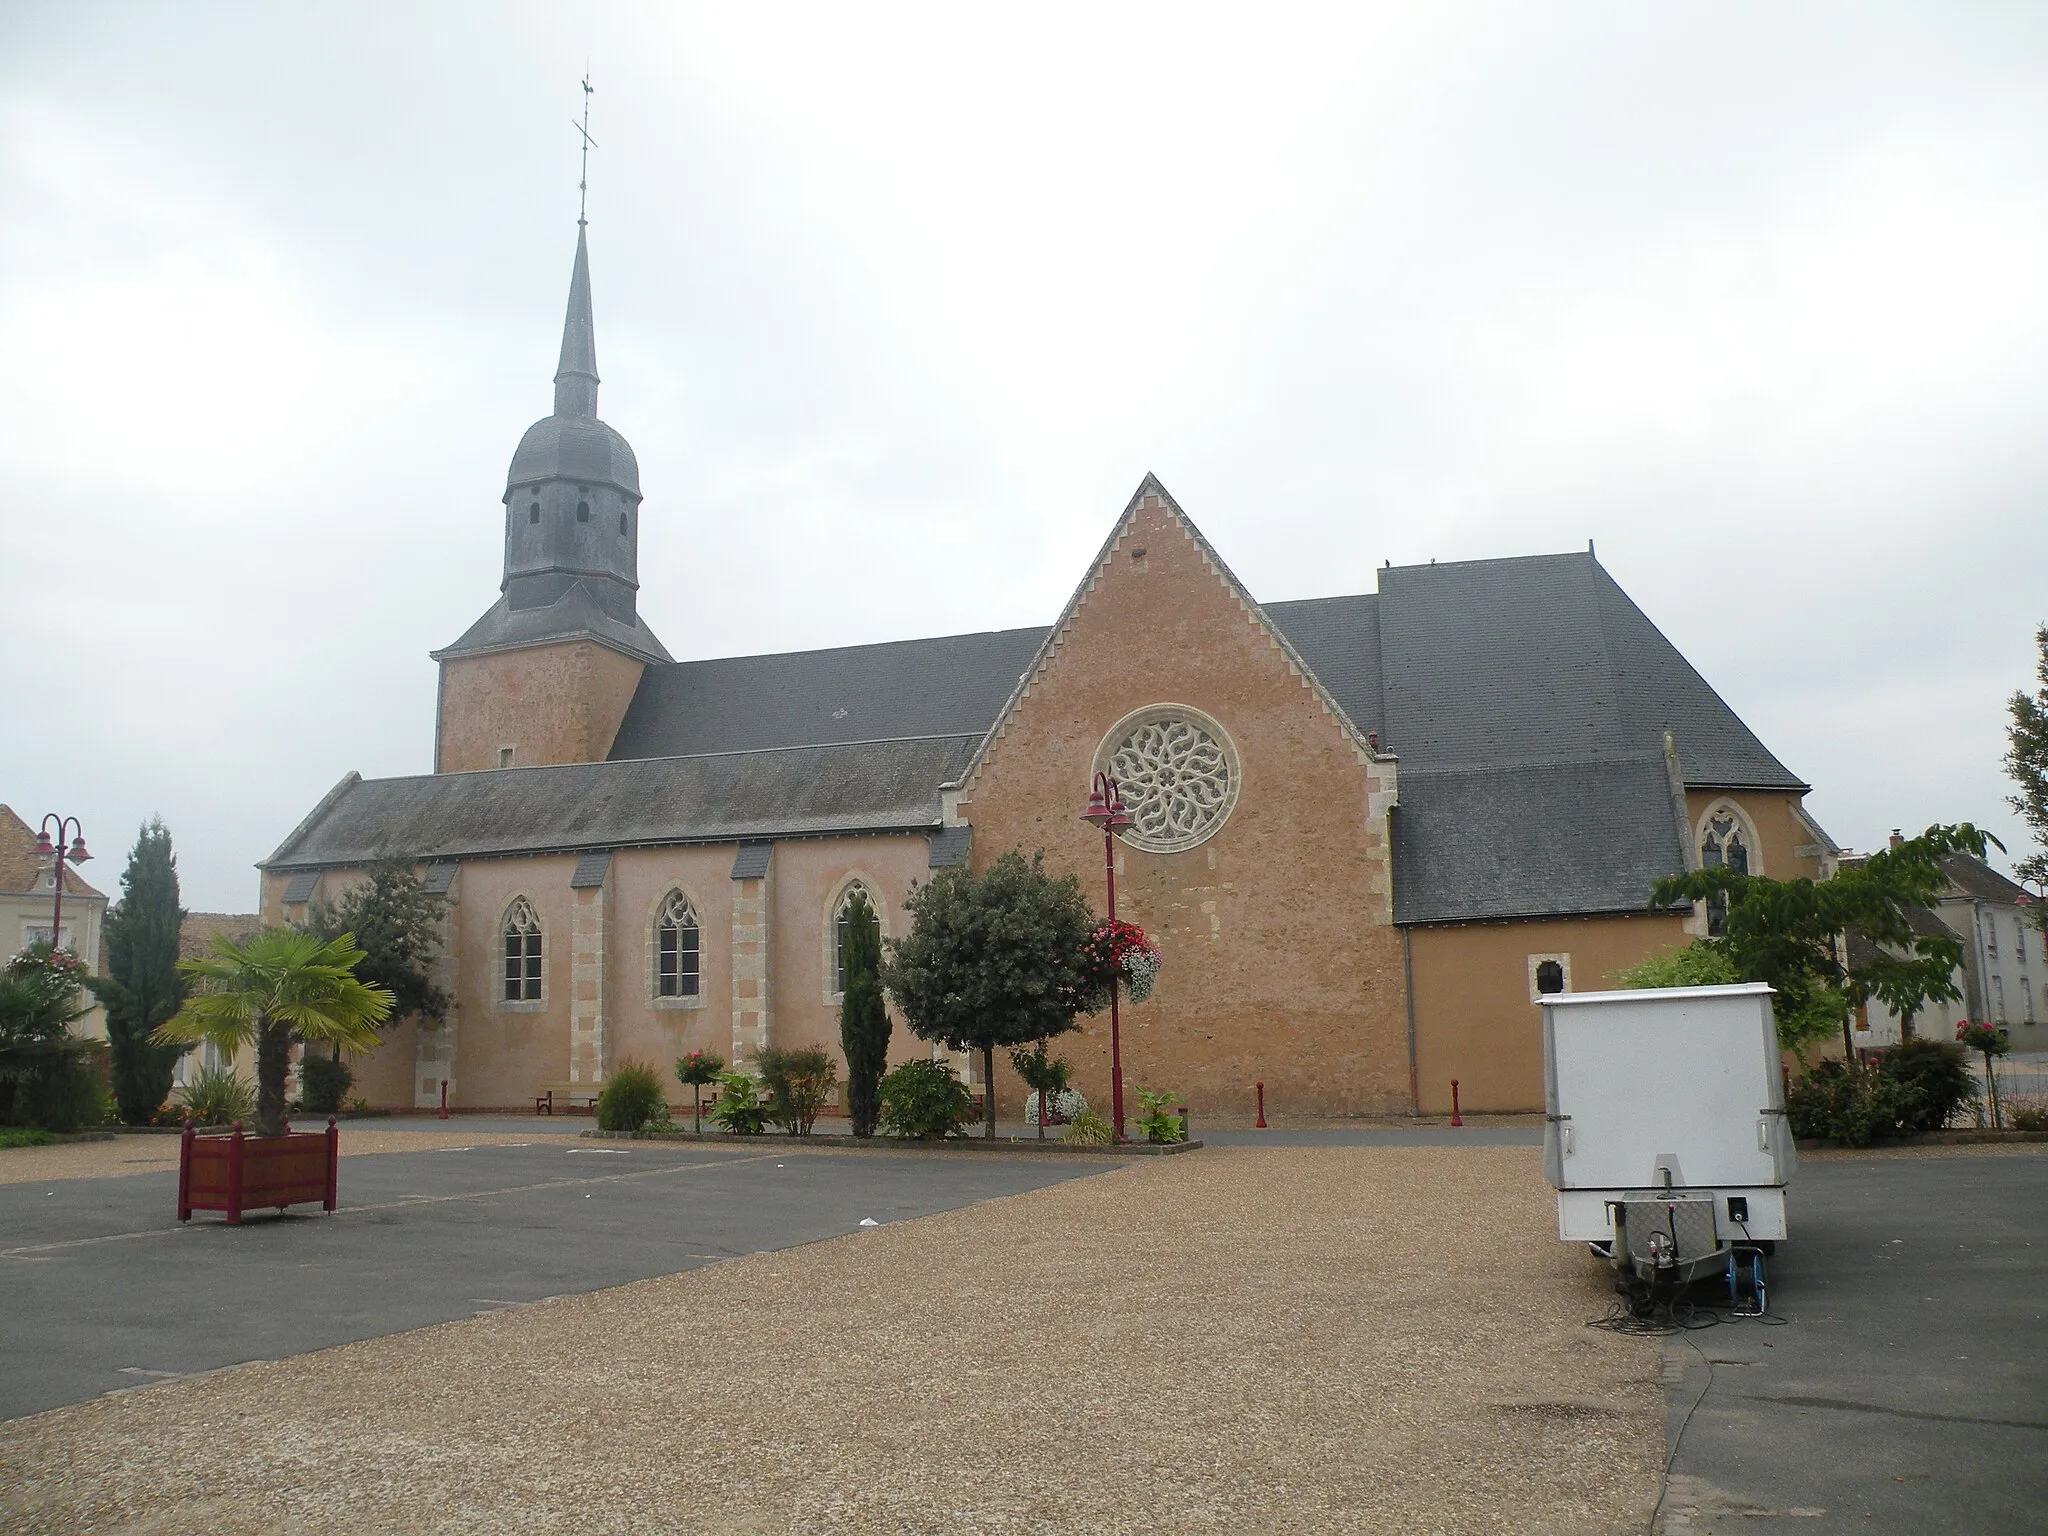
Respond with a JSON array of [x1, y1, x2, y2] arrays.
[[260, 223, 1839, 1116]]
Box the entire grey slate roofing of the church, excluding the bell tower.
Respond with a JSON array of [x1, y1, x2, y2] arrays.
[[270, 551, 1806, 924]]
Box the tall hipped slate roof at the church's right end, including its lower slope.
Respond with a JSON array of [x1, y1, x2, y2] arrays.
[[1368, 551, 1806, 924]]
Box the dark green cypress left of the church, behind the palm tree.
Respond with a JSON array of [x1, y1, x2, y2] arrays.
[[88, 817, 190, 1124]]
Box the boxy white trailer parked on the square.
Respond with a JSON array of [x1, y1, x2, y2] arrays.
[[1542, 983, 1796, 1282]]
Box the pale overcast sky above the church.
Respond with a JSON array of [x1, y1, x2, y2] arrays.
[[0, 0, 2048, 909]]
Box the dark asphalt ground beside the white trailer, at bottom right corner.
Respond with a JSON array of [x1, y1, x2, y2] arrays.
[[1663, 1153, 2048, 1536]]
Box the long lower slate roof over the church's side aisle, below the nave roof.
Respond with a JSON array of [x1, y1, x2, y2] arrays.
[[264, 735, 979, 868]]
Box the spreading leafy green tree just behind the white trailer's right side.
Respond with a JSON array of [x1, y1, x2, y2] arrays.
[[1651, 821, 1995, 1061]]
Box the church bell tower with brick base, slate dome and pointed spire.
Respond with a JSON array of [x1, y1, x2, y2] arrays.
[[434, 217, 670, 774]]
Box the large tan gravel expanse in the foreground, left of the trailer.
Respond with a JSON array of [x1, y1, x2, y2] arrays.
[[0, 1139, 1665, 1536]]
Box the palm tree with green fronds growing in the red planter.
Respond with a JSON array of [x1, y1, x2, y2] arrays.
[[150, 928, 391, 1137]]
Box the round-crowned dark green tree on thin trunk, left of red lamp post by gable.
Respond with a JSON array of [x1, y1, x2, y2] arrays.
[[883, 850, 1100, 1141]]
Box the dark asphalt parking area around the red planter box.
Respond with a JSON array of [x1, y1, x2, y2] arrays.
[[0, 1137, 1114, 1419]]
